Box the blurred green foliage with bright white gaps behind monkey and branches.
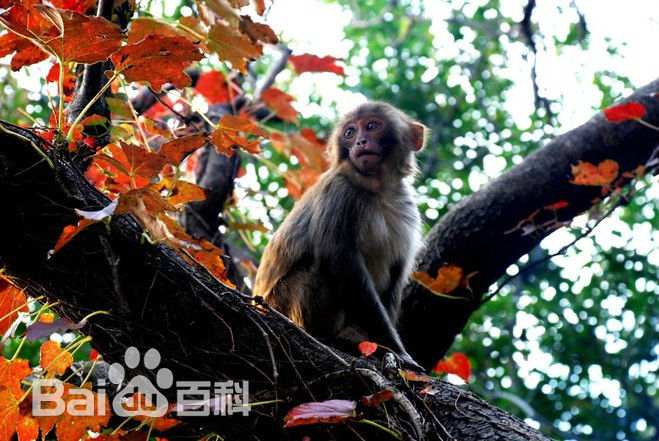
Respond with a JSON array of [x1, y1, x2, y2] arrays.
[[0, 0, 659, 440]]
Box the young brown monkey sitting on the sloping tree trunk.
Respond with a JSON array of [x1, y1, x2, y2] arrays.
[[253, 101, 428, 369]]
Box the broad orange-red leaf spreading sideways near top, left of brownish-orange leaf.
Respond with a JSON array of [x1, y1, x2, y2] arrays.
[[110, 35, 203, 91]]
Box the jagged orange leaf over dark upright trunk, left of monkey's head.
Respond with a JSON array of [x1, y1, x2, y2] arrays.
[[209, 115, 267, 156]]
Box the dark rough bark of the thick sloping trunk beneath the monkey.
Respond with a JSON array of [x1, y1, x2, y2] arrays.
[[0, 124, 547, 440]]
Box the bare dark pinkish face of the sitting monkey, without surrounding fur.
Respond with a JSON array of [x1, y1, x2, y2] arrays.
[[339, 115, 396, 175]]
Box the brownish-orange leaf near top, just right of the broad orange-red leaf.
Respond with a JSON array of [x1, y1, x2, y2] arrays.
[[204, 23, 263, 74]]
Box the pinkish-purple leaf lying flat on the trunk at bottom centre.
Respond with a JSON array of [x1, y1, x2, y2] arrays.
[[284, 400, 357, 427]]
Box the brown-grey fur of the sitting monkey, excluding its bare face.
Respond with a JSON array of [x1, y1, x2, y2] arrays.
[[254, 102, 427, 354]]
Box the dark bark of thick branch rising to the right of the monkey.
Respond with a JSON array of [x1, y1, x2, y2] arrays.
[[400, 80, 659, 366]]
